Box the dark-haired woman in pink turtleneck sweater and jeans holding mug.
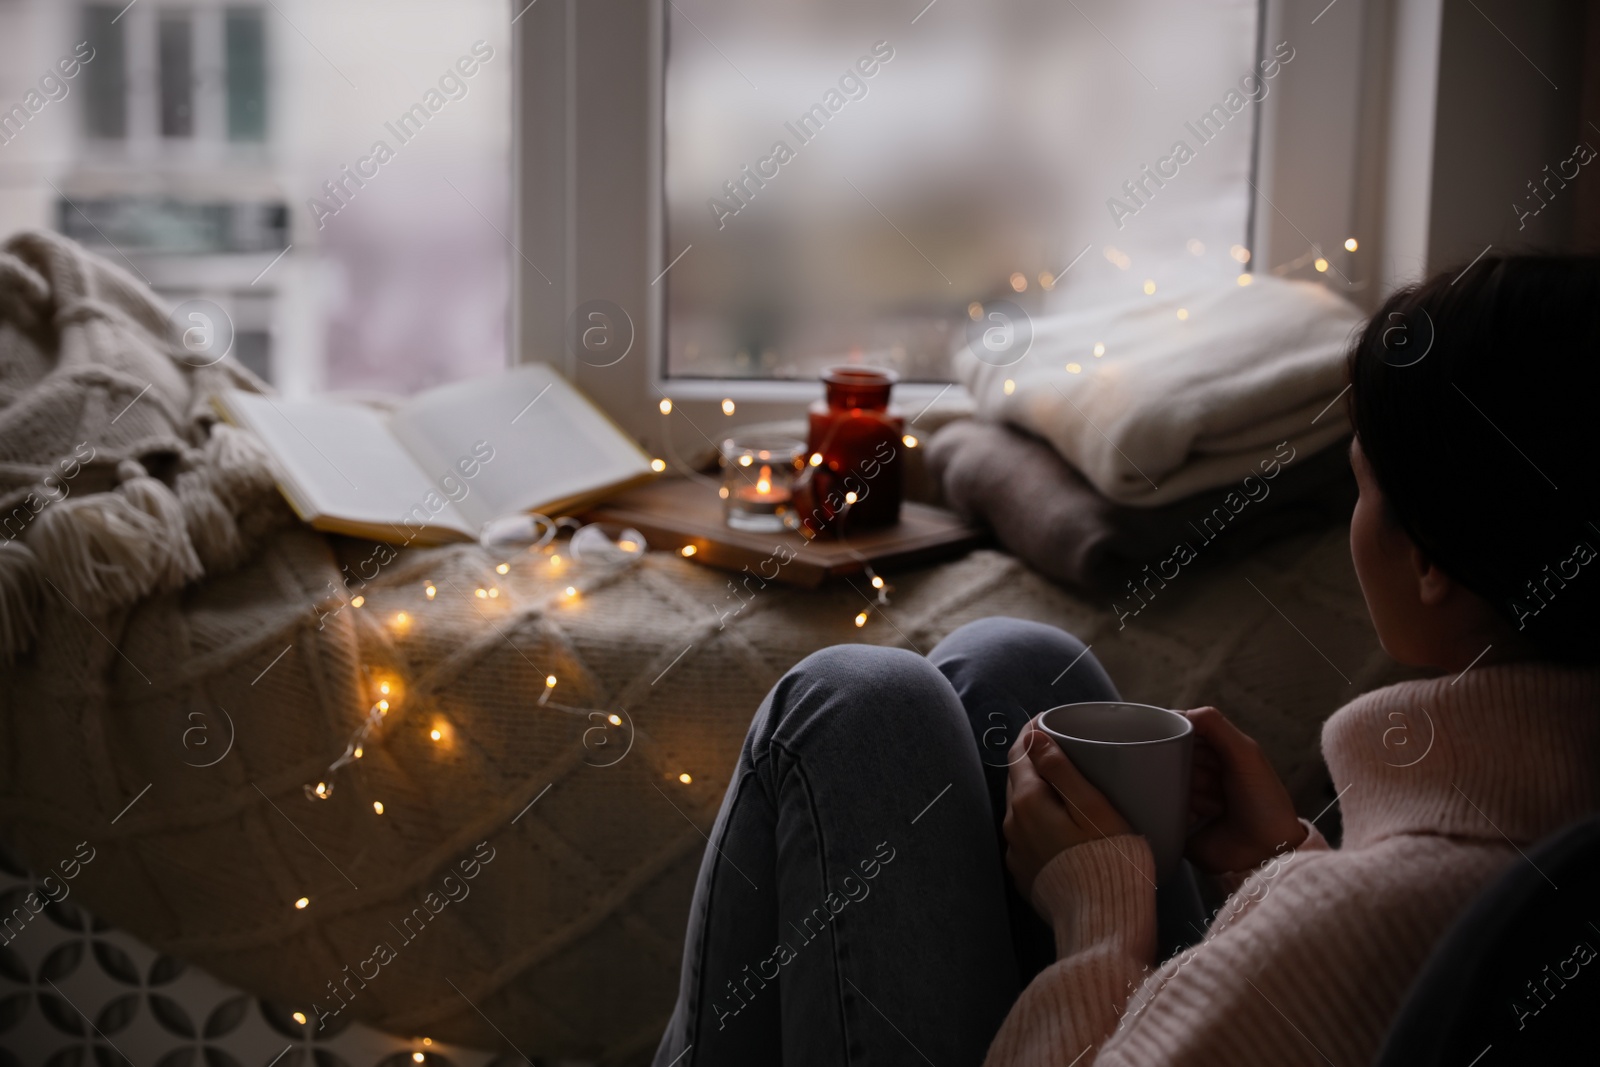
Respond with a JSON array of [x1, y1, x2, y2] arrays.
[[656, 258, 1600, 1067]]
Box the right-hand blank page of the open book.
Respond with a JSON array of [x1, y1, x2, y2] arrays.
[[389, 363, 651, 526]]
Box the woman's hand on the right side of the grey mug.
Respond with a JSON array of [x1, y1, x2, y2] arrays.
[[1184, 707, 1307, 875]]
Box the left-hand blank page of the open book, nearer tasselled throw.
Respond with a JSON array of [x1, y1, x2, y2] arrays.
[[221, 389, 477, 541]]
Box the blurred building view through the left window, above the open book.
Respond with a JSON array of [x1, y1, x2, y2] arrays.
[[0, 0, 512, 395]]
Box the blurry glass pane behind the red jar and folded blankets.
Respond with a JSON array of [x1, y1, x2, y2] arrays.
[[661, 0, 1256, 381]]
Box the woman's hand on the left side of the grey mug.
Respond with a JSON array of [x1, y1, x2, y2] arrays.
[[1005, 720, 1133, 901]]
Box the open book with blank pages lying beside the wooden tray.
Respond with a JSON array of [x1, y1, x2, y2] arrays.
[[216, 363, 654, 544]]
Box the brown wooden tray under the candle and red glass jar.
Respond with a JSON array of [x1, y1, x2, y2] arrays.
[[582, 478, 986, 587]]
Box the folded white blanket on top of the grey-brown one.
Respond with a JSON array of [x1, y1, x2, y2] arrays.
[[955, 275, 1363, 507]]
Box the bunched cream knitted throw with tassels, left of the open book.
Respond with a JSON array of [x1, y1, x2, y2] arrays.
[[0, 232, 278, 661]]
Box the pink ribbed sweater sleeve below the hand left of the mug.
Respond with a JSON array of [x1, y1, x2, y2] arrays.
[[984, 835, 1155, 1067]]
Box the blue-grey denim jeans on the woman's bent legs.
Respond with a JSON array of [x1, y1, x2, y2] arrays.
[[654, 619, 1200, 1067]]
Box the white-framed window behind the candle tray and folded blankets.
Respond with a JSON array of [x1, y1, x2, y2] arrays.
[[514, 0, 1337, 454]]
